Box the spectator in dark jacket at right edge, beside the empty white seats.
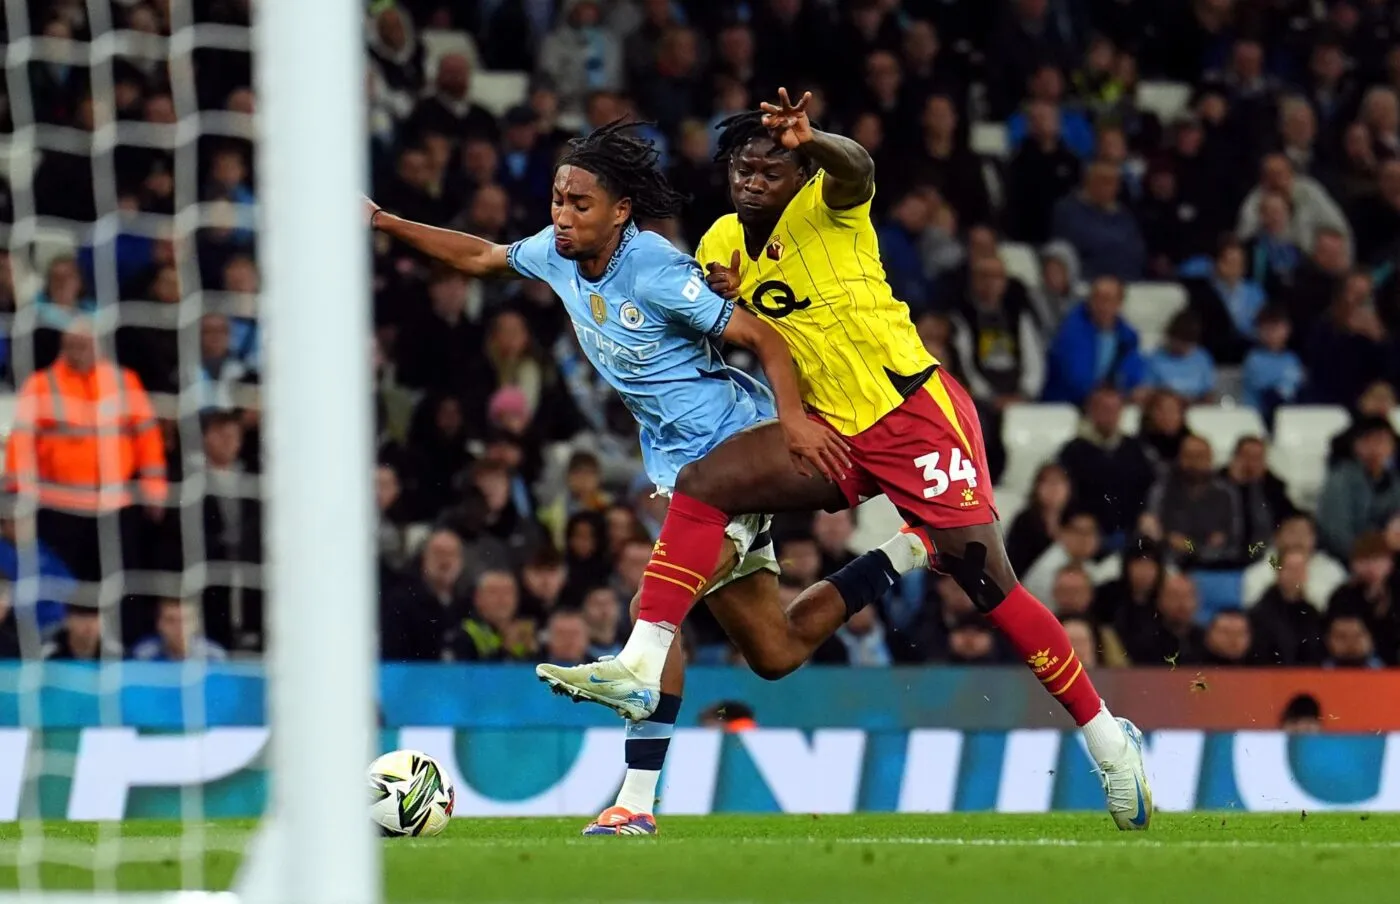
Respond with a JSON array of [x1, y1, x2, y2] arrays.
[[1317, 417, 1400, 557]]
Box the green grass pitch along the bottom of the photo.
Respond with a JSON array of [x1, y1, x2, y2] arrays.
[[0, 813, 1400, 904]]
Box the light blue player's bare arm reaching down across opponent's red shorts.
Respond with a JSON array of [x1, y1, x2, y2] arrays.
[[721, 308, 851, 480]]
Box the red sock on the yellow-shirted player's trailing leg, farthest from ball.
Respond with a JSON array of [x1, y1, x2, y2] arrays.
[[987, 584, 1102, 725]]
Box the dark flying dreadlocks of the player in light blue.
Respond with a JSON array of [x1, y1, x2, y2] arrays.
[[559, 119, 686, 220]]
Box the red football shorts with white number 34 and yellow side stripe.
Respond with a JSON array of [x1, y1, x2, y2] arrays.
[[818, 368, 998, 528]]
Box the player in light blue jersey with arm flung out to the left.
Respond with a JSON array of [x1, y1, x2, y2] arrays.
[[367, 123, 928, 835]]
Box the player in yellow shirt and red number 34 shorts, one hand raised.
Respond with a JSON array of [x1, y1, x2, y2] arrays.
[[542, 90, 1152, 828]]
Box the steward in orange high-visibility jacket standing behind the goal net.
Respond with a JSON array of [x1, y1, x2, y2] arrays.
[[6, 322, 167, 637]]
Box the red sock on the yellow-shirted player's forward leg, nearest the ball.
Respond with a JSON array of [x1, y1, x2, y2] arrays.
[[638, 494, 729, 628]]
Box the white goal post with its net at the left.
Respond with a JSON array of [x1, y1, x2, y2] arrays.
[[0, 0, 382, 904]]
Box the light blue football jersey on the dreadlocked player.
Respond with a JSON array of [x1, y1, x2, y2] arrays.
[[510, 224, 776, 490]]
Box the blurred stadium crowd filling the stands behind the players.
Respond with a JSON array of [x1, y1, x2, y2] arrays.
[[0, 0, 1400, 668]]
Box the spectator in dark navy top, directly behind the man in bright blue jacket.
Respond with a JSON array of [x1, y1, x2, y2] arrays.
[[1050, 161, 1147, 280]]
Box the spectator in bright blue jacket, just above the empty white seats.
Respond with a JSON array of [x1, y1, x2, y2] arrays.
[[1043, 276, 1145, 404]]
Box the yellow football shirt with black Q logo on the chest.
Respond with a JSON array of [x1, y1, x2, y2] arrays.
[[696, 172, 937, 437]]
